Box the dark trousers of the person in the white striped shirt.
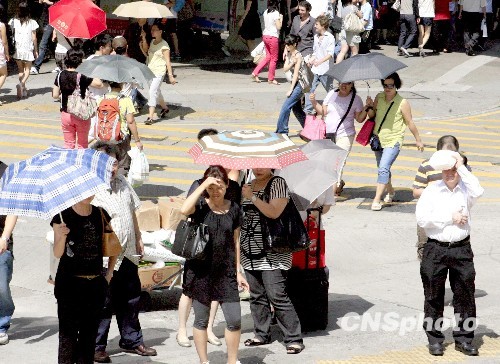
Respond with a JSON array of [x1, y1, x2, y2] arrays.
[[95, 258, 144, 351]]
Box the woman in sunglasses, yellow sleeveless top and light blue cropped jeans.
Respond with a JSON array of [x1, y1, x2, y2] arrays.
[[365, 73, 424, 211]]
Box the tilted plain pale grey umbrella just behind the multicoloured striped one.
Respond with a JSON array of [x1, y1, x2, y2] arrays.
[[276, 139, 347, 211]]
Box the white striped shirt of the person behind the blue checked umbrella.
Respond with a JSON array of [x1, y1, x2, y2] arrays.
[[92, 175, 141, 270]]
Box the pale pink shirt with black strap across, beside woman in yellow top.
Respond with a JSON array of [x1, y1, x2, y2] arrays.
[[323, 90, 363, 137]]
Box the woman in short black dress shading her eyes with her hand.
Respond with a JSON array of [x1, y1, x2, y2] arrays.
[[181, 166, 249, 364]]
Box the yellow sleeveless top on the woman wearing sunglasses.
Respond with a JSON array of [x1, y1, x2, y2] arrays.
[[373, 92, 406, 148]]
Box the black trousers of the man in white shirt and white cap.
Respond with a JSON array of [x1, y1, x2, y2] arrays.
[[420, 241, 476, 344]]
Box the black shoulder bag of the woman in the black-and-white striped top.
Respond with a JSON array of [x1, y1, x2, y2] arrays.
[[260, 177, 311, 253]]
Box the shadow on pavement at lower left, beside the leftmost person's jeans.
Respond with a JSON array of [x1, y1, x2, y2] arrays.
[[9, 316, 59, 344]]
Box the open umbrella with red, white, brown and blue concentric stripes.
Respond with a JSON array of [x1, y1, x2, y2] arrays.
[[189, 130, 307, 169]]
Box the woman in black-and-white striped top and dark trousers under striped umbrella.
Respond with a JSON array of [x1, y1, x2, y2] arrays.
[[240, 168, 304, 354]]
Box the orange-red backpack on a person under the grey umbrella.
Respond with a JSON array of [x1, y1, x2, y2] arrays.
[[94, 95, 123, 142]]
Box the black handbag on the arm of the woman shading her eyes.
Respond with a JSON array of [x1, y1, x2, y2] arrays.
[[172, 219, 210, 260]]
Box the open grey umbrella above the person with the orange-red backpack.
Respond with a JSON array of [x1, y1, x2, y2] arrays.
[[76, 55, 155, 88]]
